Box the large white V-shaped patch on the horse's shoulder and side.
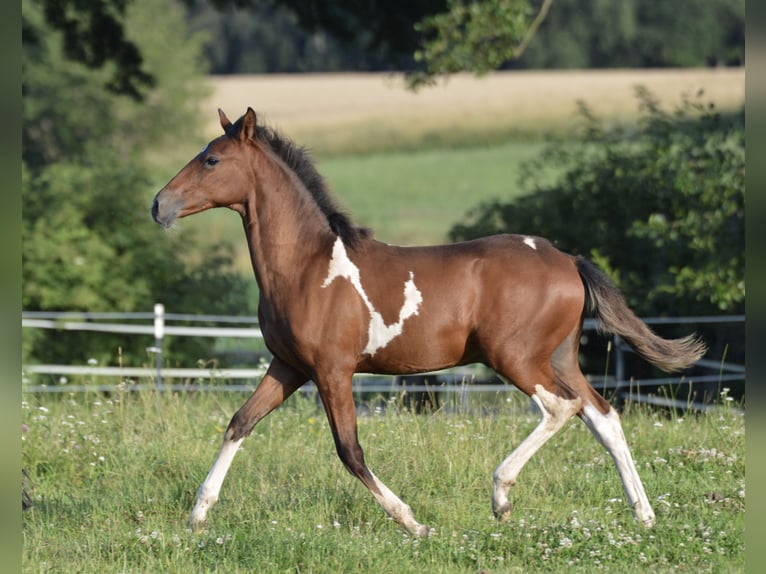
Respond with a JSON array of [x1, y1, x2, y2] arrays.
[[322, 238, 423, 355]]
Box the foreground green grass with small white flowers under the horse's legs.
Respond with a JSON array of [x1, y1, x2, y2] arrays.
[[22, 393, 745, 574]]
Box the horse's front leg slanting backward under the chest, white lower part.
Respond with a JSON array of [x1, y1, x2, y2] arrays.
[[317, 375, 431, 536]]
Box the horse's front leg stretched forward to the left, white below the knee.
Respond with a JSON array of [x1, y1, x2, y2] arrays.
[[189, 357, 307, 527]]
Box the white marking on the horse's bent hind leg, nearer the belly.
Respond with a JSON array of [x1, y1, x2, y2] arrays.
[[492, 385, 582, 520]]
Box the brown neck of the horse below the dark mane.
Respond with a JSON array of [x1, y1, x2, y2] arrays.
[[242, 154, 330, 295]]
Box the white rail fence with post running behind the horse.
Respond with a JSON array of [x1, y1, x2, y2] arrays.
[[21, 304, 745, 410]]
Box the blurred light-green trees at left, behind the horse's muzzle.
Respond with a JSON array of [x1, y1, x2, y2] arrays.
[[22, 0, 247, 361]]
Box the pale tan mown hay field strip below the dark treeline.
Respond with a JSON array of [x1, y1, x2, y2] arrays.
[[204, 68, 745, 156]]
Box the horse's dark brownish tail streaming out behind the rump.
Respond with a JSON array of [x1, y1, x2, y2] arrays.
[[575, 257, 706, 372]]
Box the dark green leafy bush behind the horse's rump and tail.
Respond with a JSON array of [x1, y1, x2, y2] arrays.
[[450, 89, 745, 315]]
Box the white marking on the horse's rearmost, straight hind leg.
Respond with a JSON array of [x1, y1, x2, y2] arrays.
[[582, 404, 654, 527]]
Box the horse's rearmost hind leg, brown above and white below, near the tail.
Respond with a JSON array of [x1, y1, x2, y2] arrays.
[[551, 331, 654, 527]]
